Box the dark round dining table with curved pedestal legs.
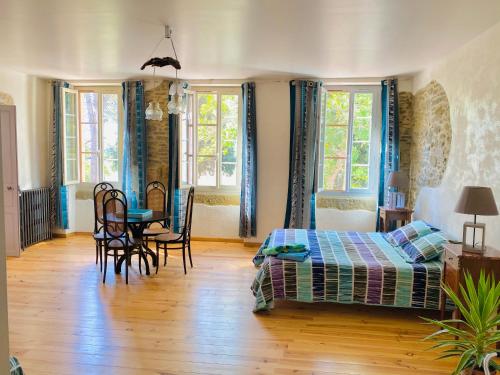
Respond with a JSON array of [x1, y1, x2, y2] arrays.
[[115, 211, 168, 275]]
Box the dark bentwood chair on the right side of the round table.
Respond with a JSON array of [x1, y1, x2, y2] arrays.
[[155, 187, 194, 274]]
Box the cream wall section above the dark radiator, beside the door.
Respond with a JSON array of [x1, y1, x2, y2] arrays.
[[0, 70, 49, 190]]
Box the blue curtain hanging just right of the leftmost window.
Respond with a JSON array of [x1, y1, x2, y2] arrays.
[[122, 81, 147, 208]]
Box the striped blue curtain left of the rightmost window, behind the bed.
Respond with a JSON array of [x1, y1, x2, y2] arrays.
[[285, 80, 322, 229]]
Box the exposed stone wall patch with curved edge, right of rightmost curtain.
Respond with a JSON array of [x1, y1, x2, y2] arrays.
[[406, 81, 451, 207]]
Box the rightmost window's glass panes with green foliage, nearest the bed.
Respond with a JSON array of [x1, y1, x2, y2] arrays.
[[319, 86, 380, 194]]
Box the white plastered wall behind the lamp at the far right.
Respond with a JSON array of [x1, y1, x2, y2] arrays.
[[414, 24, 500, 247]]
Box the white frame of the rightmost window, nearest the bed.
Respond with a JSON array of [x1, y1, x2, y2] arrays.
[[318, 85, 381, 197]]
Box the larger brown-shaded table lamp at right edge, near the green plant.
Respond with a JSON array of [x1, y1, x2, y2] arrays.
[[455, 186, 498, 253]]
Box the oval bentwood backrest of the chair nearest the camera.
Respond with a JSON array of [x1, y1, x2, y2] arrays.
[[103, 189, 128, 242]]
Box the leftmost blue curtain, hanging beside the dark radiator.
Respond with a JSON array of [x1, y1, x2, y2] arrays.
[[50, 81, 70, 229]]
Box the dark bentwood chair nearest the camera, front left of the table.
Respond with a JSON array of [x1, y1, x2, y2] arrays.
[[102, 189, 141, 284]]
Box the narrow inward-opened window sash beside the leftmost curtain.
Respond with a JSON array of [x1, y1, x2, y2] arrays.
[[62, 88, 80, 185]]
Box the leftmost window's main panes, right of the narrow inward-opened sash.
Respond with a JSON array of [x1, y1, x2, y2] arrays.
[[79, 87, 122, 183]]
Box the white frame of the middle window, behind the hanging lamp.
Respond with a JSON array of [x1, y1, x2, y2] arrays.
[[179, 86, 243, 193]]
